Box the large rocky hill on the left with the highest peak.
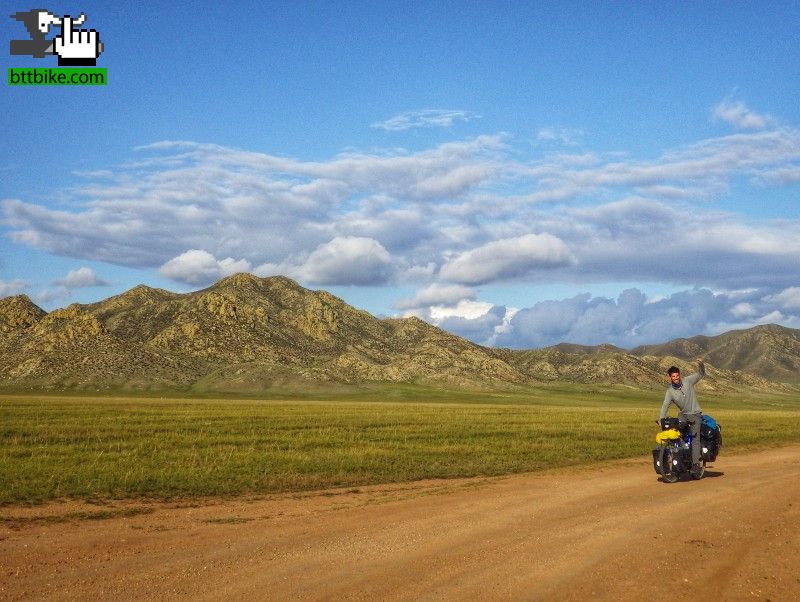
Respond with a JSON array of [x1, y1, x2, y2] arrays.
[[0, 274, 527, 392]]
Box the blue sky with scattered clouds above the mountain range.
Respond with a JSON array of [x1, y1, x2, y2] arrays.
[[0, 1, 800, 347]]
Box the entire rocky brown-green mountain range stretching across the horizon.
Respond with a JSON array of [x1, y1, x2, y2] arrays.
[[0, 274, 800, 394]]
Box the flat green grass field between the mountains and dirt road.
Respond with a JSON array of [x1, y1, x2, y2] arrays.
[[0, 385, 800, 504]]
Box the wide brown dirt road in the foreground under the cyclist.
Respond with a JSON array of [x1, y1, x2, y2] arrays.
[[0, 446, 800, 600]]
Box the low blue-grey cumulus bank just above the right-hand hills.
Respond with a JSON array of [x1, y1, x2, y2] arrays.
[[432, 288, 800, 349]]
